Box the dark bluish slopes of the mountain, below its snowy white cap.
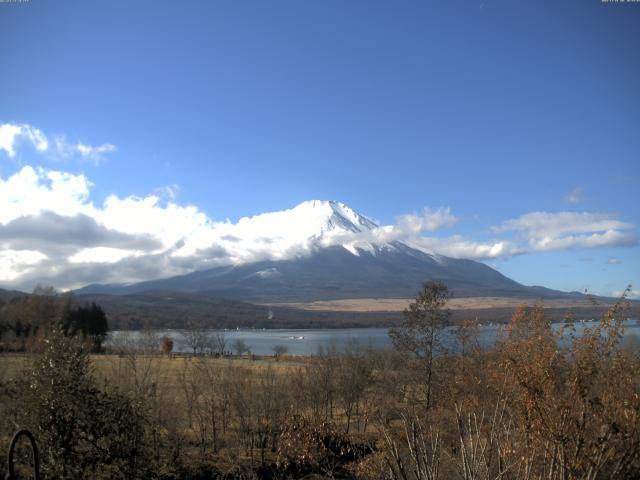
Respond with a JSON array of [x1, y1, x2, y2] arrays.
[[76, 246, 576, 302]]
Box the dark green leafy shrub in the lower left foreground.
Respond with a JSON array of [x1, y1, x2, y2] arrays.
[[23, 329, 150, 480]]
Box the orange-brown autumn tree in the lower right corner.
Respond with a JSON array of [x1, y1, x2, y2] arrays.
[[498, 303, 640, 480]]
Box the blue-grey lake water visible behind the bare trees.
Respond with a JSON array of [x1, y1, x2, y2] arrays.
[[107, 320, 640, 355]]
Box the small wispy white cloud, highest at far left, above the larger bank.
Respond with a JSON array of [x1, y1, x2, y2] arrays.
[[0, 123, 116, 164]]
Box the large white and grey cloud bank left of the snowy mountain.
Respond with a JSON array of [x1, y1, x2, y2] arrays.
[[0, 166, 218, 287]]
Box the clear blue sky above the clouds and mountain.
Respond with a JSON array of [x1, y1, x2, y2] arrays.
[[0, 0, 640, 294]]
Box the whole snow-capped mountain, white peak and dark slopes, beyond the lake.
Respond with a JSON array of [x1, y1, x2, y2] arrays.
[[76, 200, 574, 303]]
